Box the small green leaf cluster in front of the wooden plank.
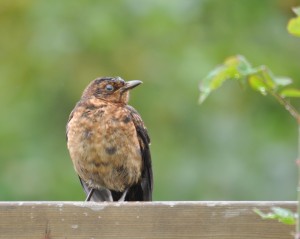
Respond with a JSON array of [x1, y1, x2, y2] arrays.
[[254, 207, 297, 225]]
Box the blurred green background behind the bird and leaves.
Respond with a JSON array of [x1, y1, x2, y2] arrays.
[[0, 0, 300, 200]]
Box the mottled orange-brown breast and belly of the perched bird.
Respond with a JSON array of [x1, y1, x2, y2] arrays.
[[68, 104, 142, 191]]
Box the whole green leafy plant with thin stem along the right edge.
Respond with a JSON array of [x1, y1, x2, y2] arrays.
[[199, 5, 300, 235]]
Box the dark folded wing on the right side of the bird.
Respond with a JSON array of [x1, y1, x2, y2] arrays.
[[125, 106, 153, 201]]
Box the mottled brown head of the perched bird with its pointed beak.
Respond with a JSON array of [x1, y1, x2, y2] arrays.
[[81, 77, 142, 104]]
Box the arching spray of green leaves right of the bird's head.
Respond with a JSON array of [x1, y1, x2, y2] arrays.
[[199, 55, 300, 113]]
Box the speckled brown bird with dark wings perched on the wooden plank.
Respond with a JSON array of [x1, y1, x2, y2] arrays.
[[66, 77, 153, 202]]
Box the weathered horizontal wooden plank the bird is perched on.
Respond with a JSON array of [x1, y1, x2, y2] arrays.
[[0, 202, 296, 239]]
